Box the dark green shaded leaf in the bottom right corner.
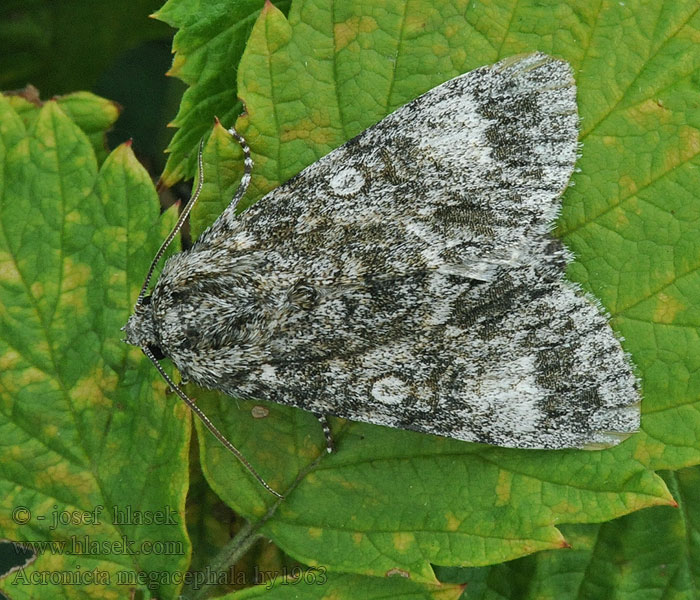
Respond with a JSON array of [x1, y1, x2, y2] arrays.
[[440, 467, 700, 600]]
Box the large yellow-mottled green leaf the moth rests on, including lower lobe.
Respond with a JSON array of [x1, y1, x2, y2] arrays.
[[182, 0, 700, 582]]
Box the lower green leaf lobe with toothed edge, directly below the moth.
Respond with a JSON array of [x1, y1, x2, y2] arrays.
[[197, 392, 671, 582]]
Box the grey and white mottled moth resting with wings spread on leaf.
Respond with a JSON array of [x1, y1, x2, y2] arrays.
[[125, 53, 640, 492]]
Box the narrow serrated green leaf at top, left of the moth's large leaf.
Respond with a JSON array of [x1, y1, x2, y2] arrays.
[[153, 0, 289, 185]]
